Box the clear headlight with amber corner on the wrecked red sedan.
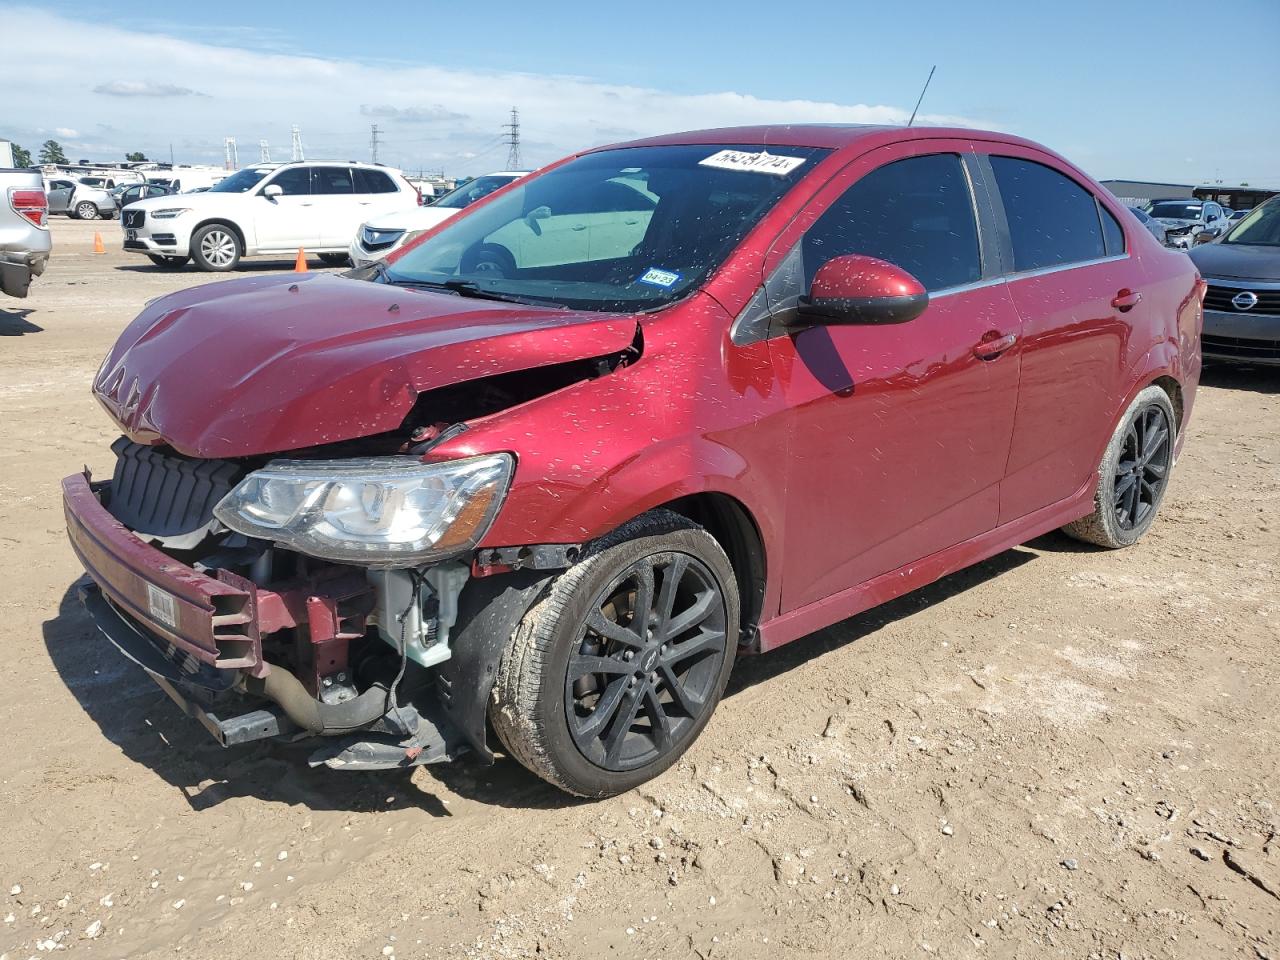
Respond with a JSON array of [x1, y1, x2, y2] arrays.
[[214, 453, 515, 567]]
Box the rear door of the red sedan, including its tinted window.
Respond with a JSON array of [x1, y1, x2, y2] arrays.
[[979, 146, 1153, 522]]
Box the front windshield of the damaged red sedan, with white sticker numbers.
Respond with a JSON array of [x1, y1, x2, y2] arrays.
[[381, 145, 829, 311]]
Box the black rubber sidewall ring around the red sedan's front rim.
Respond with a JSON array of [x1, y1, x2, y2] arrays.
[[509, 529, 740, 796]]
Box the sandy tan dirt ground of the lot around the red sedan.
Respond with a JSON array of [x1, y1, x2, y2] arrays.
[[0, 218, 1280, 960]]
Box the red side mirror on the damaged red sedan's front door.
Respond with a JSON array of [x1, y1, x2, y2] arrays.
[[796, 253, 929, 324]]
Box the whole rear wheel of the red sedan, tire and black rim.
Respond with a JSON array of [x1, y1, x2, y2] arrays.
[[1062, 385, 1178, 549]]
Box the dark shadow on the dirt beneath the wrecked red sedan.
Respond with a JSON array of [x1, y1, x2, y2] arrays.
[[44, 535, 1039, 817]]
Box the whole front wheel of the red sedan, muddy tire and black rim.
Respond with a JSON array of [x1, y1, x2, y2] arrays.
[[489, 511, 739, 797]]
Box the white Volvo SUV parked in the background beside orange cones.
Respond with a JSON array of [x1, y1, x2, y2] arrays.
[[120, 160, 419, 271]]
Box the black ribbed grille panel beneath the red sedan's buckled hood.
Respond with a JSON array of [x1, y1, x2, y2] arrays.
[[106, 436, 243, 547]]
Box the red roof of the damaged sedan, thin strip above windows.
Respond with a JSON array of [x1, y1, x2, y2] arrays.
[[589, 123, 1043, 152]]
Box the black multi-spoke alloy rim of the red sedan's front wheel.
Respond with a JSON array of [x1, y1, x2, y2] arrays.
[[564, 553, 728, 771]]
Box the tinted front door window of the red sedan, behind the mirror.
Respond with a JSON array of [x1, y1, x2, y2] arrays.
[[803, 154, 982, 292]]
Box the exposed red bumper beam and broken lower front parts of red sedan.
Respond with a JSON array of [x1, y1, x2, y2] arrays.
[[63, 475, 483, 769]]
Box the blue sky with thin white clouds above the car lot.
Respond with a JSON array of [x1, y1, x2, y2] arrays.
[[0, 0, 1280, 187]]
